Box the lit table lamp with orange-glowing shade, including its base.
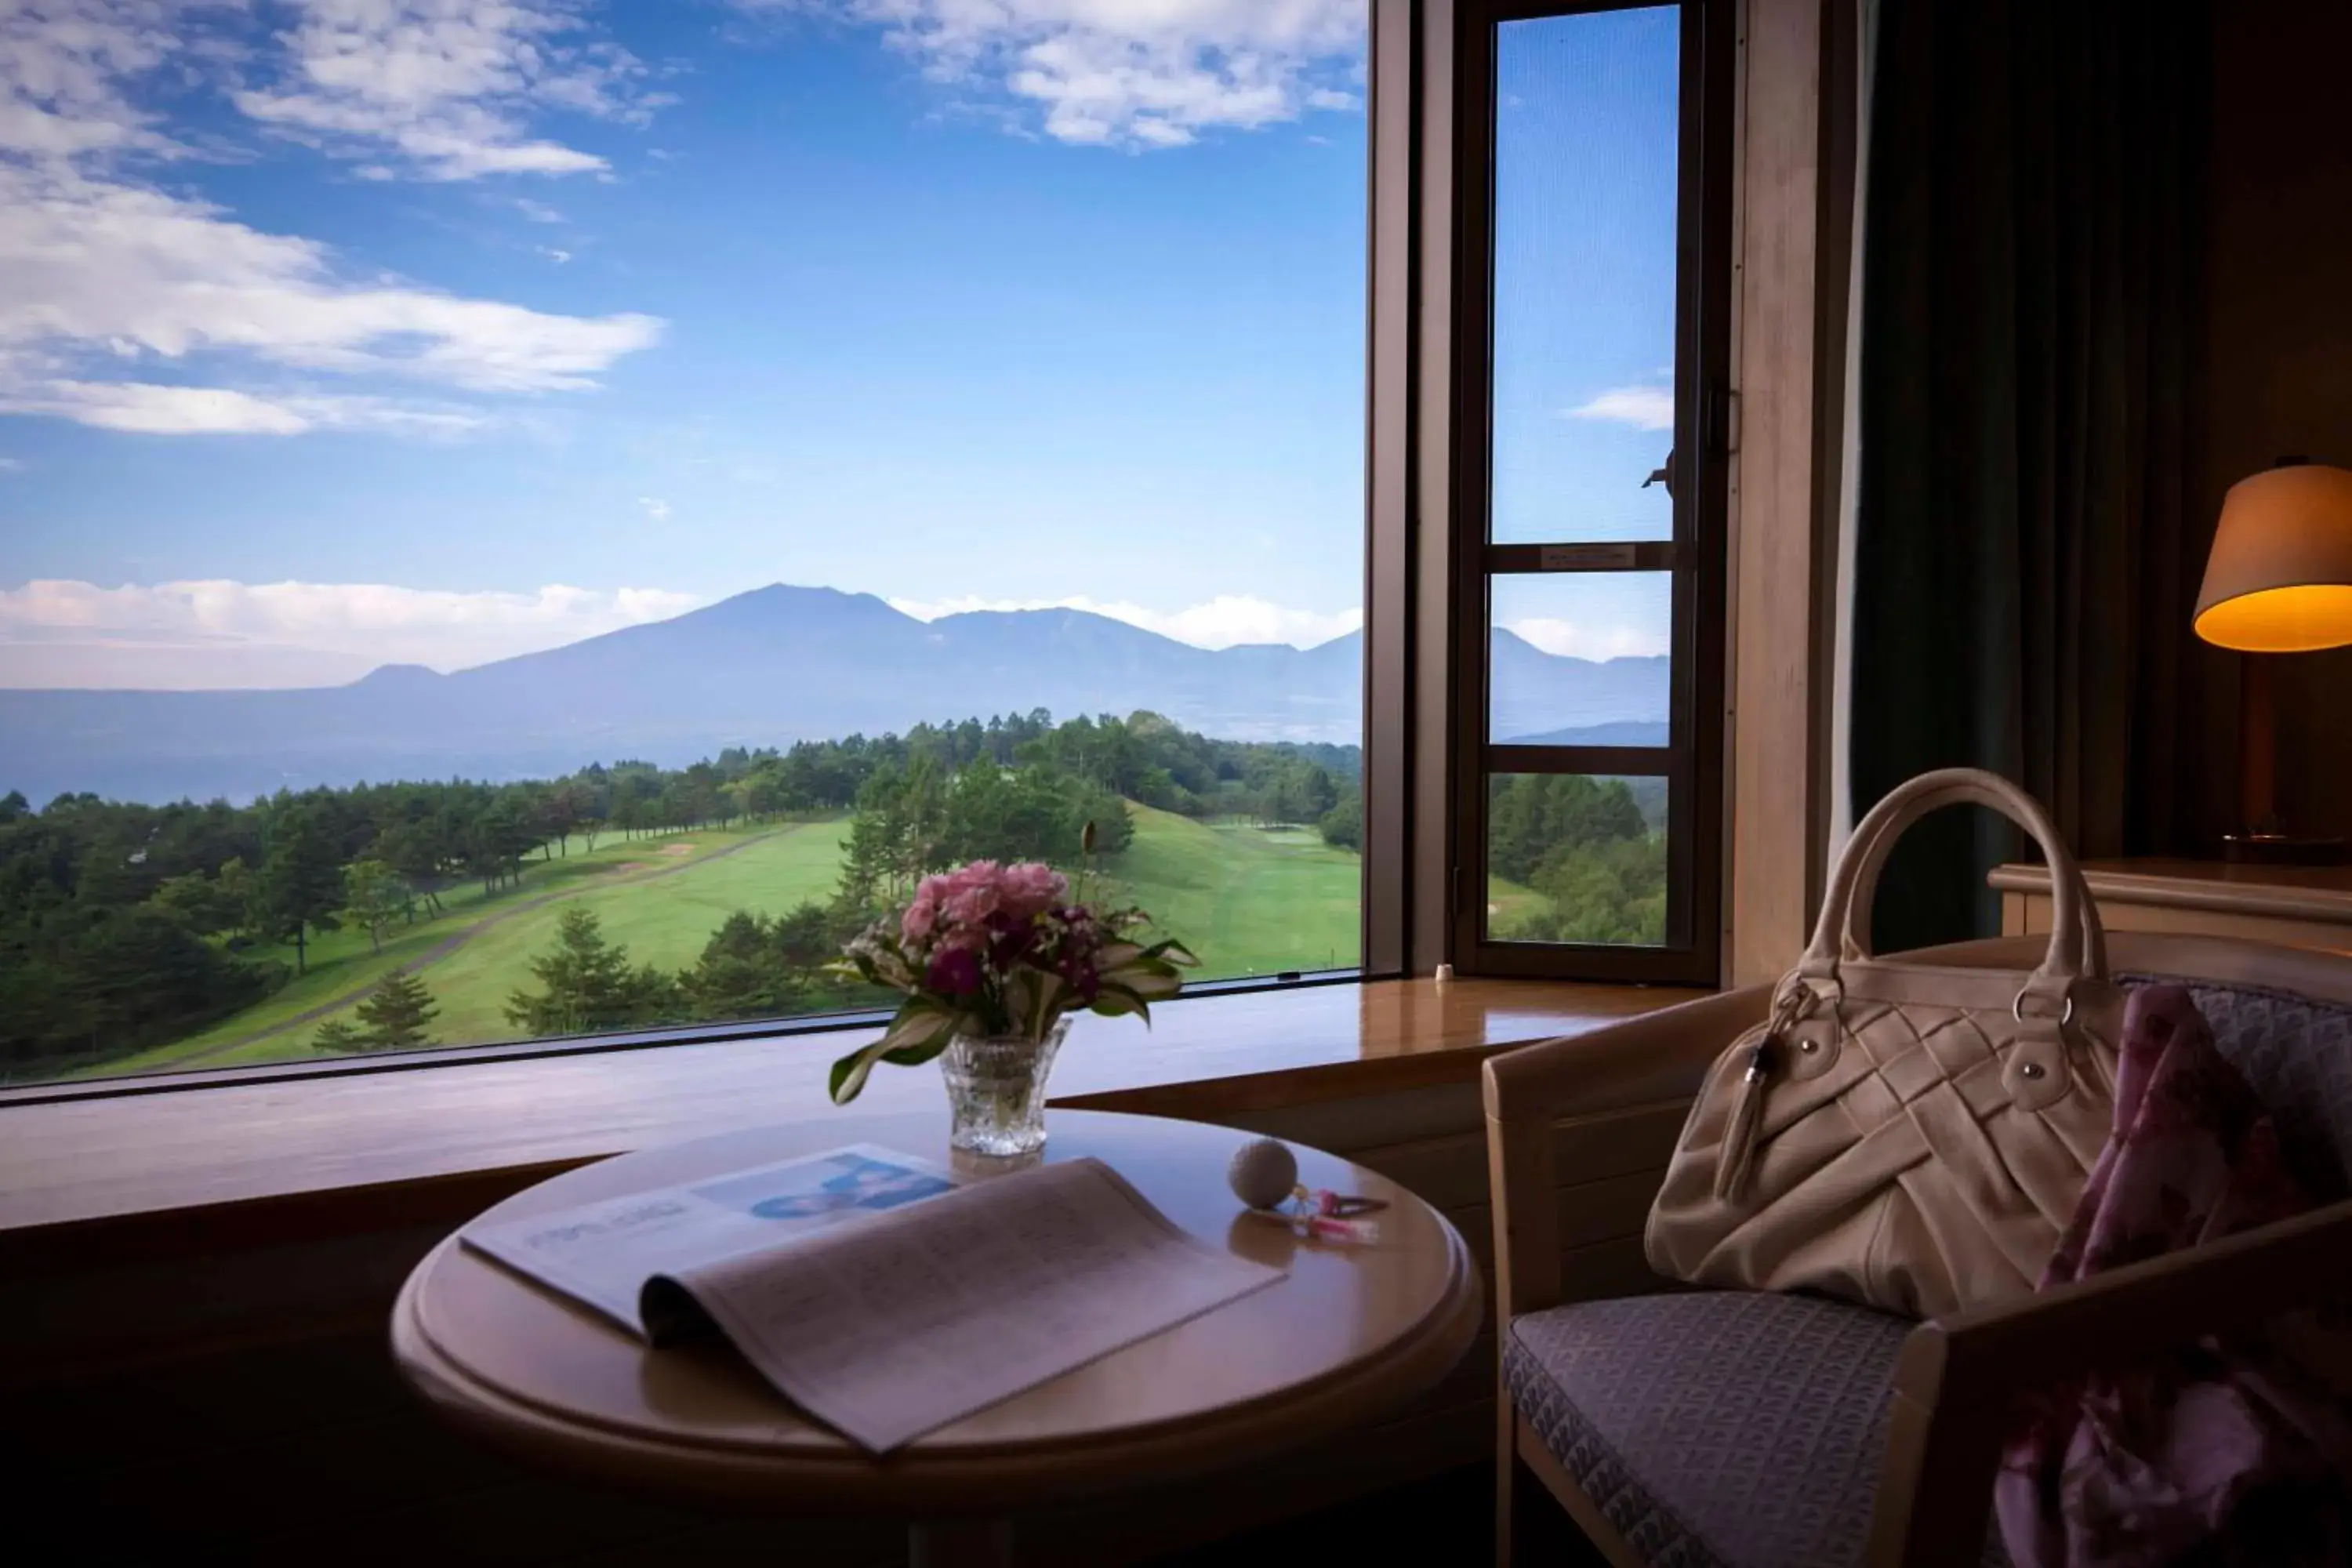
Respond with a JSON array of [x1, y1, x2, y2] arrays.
[[2197, 459, 2352, 865]]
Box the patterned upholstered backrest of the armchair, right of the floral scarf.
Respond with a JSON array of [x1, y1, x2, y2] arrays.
[[2117, 975, 2352, 1203]]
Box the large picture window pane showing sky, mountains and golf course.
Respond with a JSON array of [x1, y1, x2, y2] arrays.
[[0, 0, 1374, 1083]]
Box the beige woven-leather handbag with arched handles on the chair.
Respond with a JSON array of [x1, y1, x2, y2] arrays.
[[1646, 769, 2124, 1316]]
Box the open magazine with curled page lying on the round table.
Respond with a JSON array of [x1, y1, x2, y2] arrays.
[[461, 1145, 1282, 1453]]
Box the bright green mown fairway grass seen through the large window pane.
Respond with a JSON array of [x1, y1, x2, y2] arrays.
[[106, 806, 1362, 1074]]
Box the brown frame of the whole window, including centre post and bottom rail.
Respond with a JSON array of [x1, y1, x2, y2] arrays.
[[0, 0, 1736, 1109]]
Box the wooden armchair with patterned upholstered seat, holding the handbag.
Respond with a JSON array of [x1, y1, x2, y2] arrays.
[[1486, 933, 2352, 1568]]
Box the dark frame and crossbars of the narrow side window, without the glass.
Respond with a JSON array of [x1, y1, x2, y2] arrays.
[[1449, 0, 1738, 985]]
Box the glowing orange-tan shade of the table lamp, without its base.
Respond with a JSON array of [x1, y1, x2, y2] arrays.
[[2197, 463, 2352, 654]]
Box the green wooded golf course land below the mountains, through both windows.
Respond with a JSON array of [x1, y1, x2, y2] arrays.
[[0, 713, 1665, 1081]]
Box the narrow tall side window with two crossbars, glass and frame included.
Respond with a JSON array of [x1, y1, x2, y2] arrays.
[[1454, 0, 1731, 982]]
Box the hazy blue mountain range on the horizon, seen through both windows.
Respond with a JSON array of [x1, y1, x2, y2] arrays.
[[0, 583, 1668, 801]]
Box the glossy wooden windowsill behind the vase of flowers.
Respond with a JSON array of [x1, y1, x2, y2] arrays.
[[0, 980, 1700, 1265]]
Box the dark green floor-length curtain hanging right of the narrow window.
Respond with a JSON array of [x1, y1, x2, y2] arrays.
[[1849, 0, 2234, 949]]
